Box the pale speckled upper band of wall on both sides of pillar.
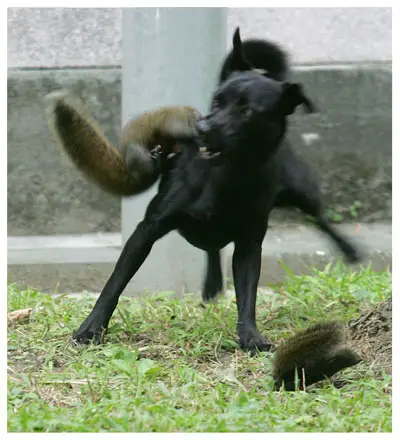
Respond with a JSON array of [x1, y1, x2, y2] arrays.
[[8, 8, 392, 67]]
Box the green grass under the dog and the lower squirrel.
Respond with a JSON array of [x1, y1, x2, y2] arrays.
[[8, 266, 391, 432]]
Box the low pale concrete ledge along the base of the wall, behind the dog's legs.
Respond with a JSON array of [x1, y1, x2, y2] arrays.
[[8, 223, 392, 295]]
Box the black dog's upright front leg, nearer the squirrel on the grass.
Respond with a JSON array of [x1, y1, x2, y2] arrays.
[[232, 241, 273, 352]]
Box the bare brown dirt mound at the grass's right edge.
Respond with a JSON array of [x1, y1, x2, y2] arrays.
[[349, 299, 392, 375]]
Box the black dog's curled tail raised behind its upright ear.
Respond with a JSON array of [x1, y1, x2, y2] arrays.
[[219, 33, 290, 83]]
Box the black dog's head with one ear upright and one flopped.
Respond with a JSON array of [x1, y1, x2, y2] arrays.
[[197, 29, 314, 163]]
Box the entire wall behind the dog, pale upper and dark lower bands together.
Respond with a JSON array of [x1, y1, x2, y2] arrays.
[[8, 8, 392, 235]]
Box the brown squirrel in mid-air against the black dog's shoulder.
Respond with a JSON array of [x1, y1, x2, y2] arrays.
[[44, 90, 201, 196]]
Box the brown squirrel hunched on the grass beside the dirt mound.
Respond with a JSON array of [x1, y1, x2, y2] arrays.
[[272, 322, 362, 391]]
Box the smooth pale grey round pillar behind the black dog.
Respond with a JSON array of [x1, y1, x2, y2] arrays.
[[122, 8, 226, 293]]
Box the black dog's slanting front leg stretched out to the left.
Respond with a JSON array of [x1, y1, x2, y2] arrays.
[[73, 170, 195, 344]]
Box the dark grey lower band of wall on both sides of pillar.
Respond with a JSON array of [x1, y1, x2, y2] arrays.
[[8, 63, 392, 235]]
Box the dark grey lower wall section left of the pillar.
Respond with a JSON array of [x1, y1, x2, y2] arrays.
[[7, 69, 121, 235]]
